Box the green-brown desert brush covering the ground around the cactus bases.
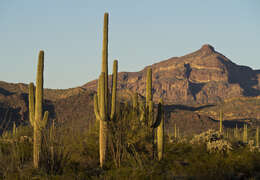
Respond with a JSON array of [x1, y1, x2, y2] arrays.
[[0, 103, 260, 179]]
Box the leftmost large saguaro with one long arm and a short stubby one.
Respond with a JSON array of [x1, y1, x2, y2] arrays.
[[29, 51, 49, 168]]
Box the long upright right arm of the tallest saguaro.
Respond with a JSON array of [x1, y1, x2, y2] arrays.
[[110, 60, 118, 119]]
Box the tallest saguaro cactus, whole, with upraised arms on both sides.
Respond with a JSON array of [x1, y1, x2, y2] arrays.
[[94, 13, 118, 167]]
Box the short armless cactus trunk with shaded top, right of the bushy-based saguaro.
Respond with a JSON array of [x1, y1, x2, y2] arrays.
[[157, 99, 164, 161]]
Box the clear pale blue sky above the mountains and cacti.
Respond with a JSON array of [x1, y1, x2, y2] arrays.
[[0, 0, 260, 89]]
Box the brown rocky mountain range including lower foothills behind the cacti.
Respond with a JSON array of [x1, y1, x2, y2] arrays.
[[0, 45, 260, 133]]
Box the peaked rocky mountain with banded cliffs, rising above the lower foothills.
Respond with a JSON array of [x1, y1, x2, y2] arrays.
[[82, 44, 260, 104]]
